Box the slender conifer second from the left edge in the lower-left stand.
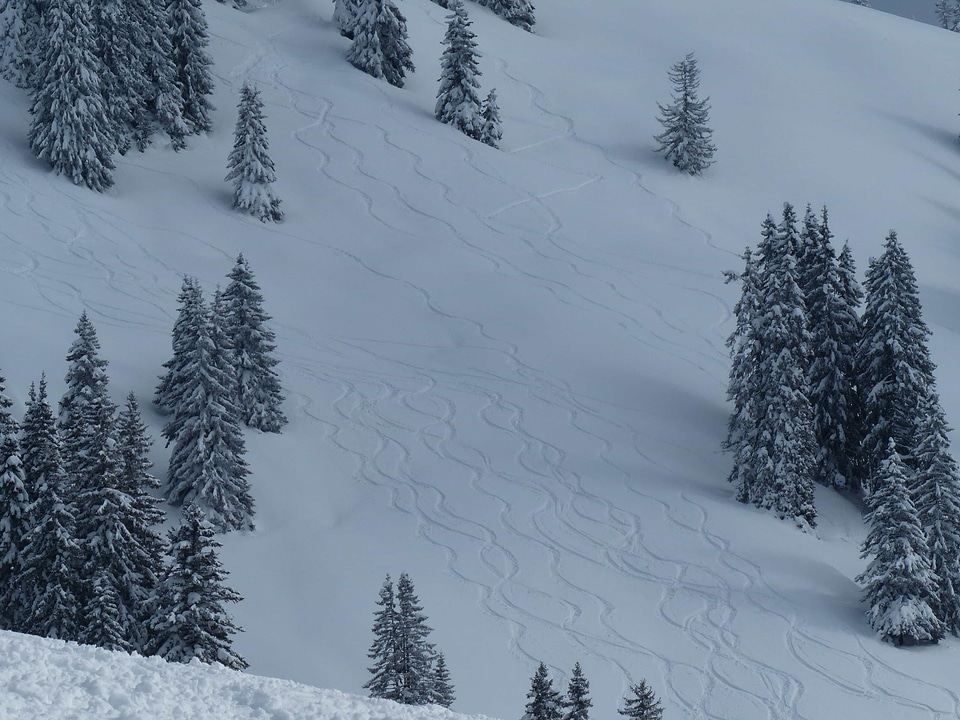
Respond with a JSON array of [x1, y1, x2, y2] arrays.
[[17, 377, 82, 640]]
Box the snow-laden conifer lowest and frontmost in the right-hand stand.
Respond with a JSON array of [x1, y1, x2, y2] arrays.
[[857, 438, 944, 645]]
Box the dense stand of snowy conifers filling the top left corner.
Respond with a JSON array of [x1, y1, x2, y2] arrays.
[[0, 0, 213, 191]]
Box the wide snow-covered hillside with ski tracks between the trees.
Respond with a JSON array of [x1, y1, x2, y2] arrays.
[[0, 0, 960, 720]]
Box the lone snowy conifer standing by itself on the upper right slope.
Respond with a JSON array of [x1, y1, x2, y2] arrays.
[[654, 53, 716, 175]]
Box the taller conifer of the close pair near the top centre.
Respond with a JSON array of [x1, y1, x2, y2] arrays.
[[434, 0, 484, 140]]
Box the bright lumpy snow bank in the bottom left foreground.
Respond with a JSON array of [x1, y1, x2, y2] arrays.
[[0, 632, 496, 720]]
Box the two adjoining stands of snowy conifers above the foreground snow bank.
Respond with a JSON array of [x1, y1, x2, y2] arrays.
[[0, 255, 286, 669]]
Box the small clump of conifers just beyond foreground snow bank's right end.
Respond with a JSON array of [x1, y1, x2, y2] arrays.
[[363, 573, 455, 707]]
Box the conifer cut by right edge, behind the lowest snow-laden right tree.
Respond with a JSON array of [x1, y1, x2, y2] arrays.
[[911, 397, 960, 635]]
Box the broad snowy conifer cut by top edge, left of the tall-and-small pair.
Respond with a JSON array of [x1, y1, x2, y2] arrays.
[[347, 0, 415, 87]]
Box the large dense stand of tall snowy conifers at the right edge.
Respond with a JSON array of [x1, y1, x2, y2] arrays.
[[725, 204, 960, 644]]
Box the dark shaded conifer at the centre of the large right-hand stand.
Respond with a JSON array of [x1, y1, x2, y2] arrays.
[[804, 208, 860, 490]]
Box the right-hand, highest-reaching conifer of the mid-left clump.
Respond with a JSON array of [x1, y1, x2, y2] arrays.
[[222, 254, 287, 432]]
